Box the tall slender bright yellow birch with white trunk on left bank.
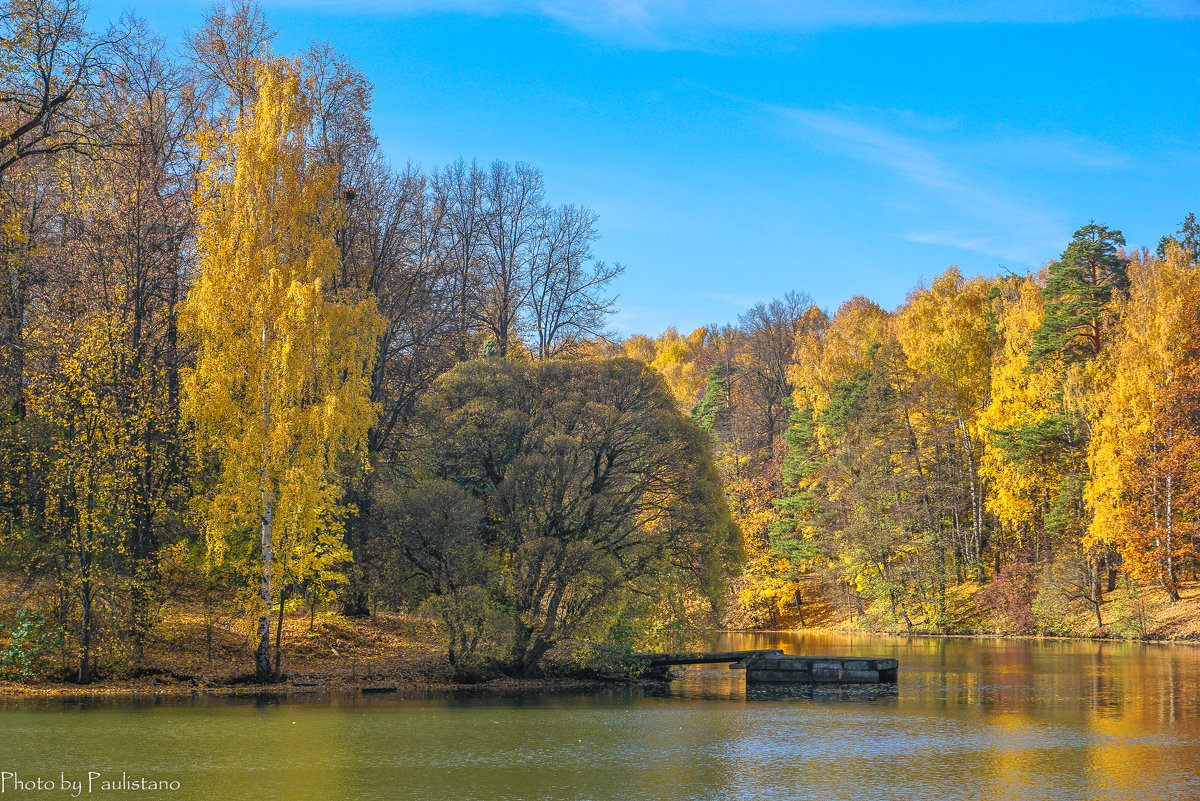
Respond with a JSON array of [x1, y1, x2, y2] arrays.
[[181, 59, 383, 680]]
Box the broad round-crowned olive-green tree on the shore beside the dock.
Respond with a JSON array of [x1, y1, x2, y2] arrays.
[[410, 359, 740, 675]]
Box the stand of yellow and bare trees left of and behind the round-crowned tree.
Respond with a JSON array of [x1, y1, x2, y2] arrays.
[[0, 0, 643, 681]]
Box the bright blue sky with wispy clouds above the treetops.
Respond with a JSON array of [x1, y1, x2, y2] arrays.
[[84, 0, 1200, 333]]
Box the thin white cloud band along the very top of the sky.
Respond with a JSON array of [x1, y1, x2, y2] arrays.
[[269, 0, 1200, 48]]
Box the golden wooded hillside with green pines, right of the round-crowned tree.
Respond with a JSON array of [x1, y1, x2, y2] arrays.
[[623, 225, 1200, 637]]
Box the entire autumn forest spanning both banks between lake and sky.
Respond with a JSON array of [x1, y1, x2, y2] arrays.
[[0, 0, 1200, 682]]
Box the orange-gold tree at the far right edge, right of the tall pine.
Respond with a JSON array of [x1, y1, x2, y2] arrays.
[[1087, 251, 1200, 598]]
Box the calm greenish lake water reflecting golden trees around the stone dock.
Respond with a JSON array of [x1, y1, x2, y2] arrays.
[[0, 633, 1200, 801]]
